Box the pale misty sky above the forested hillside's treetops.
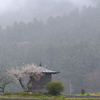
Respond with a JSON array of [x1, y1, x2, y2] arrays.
[[0, 0, 100, 25]]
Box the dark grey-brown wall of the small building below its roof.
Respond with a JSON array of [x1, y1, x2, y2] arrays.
[[32, 74, 52, 92]]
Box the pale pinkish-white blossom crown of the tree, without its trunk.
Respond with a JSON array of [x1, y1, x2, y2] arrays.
[[7, 63, 43, 81]]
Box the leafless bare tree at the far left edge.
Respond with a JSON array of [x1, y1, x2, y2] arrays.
[[0, 71, 12, 93]]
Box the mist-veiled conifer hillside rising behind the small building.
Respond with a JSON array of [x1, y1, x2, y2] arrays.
[[0, 5, 100, 93]]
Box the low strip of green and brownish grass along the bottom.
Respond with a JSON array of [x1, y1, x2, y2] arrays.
[[0, 92, 100, 100]]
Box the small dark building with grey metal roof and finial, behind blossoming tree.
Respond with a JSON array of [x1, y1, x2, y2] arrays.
[[31, 63, 60, 92]]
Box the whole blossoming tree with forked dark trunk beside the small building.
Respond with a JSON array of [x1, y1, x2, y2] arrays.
[[7, 63, 43, 91]]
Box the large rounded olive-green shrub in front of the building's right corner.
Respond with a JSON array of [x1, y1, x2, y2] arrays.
[[46, 81, 64, 95]]
